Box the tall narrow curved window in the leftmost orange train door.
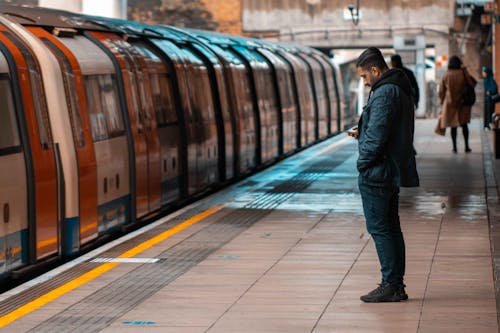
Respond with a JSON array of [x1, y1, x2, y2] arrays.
[[4, 32, 52, 149]]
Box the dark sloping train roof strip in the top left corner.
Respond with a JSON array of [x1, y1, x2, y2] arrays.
[[0, 4, 108, 31]]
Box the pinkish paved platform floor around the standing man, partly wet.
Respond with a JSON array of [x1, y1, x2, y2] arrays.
[[4, 120, 498, 333]]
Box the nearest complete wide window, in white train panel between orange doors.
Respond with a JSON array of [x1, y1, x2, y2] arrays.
[[84, 74, 125, 141]]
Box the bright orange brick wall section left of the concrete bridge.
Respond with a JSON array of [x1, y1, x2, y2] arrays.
[[202, 0, 242, 35]]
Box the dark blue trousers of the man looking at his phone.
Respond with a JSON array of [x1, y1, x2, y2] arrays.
[[359, 183, 405, 285]]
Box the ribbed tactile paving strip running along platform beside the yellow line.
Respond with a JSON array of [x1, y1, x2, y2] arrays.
[[23, 150, 345, 332]]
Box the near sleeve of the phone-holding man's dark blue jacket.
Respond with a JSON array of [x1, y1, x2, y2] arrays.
[[357, 85, 399, 171]]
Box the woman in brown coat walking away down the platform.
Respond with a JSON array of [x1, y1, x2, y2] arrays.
[[439, 56, 474, 154]]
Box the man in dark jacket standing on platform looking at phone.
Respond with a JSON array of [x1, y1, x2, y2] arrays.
[[348, 47, 419, 303]]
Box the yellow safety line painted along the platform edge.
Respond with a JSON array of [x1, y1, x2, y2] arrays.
[[0, 205, 222, 328]]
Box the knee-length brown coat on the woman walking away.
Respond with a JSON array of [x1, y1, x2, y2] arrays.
[[439, 69, 473, 128]]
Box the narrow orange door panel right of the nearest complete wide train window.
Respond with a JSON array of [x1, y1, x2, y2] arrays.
[[88, 31, 149, 222]]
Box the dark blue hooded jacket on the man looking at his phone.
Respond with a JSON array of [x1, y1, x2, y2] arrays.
[[357, 69, 419, 187]]
